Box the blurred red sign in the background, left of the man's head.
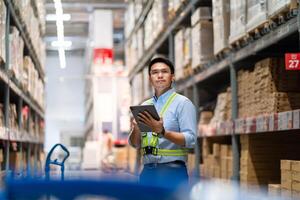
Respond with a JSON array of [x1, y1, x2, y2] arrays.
[[94, 48, 113, 65]]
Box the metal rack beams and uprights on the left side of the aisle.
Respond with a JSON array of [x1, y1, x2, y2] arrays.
[[0, 0, 45, 176]]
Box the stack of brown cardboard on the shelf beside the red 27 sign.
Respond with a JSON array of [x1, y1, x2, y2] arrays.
[[254, 58, 300, 115]]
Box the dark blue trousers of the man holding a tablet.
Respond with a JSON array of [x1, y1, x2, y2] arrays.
[[140, 161, 188, 189]]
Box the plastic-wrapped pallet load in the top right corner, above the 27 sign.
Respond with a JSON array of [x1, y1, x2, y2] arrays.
[[268, 0, 297, 17]]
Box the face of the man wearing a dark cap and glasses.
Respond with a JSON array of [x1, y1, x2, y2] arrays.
[[149, 62, 174, 90]]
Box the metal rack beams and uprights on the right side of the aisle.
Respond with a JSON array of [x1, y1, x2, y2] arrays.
[[129, 1, 300, 180]]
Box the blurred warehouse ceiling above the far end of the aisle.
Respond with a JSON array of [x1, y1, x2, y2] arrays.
[[45, 0, 126, 53]]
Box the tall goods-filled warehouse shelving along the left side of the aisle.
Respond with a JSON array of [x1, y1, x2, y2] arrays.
[[0, 0, 45, 177]]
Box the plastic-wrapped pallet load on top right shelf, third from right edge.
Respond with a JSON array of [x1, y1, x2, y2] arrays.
[[229, 0, 246, 44]]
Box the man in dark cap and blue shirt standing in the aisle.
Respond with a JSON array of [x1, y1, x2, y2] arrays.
[[129, 57, 197, 187]]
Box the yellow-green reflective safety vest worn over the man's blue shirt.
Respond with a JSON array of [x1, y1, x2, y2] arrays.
[[141, 92, 189, 156]]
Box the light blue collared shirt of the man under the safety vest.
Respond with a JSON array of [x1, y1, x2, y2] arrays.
[[143, 88, 197, 164]]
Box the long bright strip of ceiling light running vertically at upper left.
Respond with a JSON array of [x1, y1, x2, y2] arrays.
[[53, 0, 66, 69]]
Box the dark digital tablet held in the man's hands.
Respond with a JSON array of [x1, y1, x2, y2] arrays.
[[130, 105, 160, 132]]
